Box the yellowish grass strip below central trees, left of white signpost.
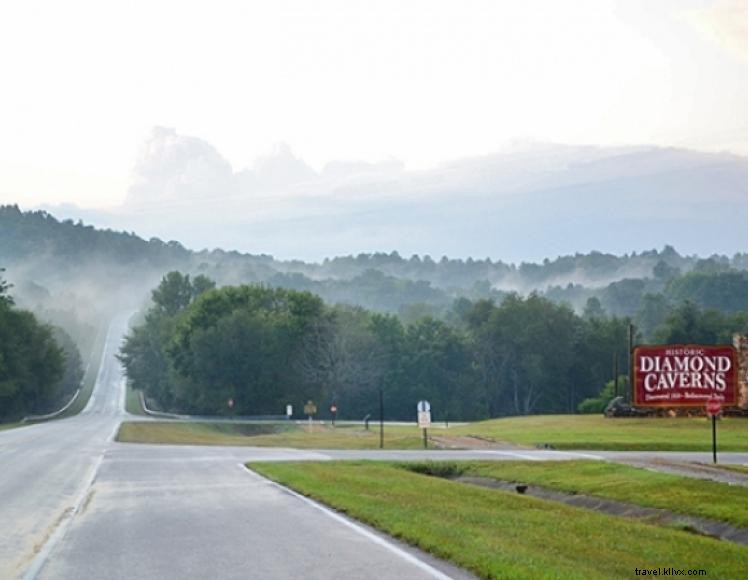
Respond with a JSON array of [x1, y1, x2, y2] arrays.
[[117, 421, 423, 449]]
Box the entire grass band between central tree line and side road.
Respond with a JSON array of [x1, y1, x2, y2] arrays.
[[115, 415, 748, 451]]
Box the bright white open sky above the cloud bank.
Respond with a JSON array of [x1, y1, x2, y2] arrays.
[[0, 0, 748, 208]]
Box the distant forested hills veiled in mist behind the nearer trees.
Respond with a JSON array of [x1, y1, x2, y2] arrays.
[[0, 206, 748, 324]]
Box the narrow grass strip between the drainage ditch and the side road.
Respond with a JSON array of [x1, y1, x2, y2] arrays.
[[404, 461, 748, 527]]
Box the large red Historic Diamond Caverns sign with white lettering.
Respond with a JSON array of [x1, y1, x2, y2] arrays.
[[634, 344, 737, 407]]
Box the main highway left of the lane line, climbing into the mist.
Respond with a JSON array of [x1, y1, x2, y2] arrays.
[[0, 317, 126, 578]]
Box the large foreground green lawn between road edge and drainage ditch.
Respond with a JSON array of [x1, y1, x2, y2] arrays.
[[249, 462, 748, 579]]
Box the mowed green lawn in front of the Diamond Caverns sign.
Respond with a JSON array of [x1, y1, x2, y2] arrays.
[[449, 415, 748, 451]]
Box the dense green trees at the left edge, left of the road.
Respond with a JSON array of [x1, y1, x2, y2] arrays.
[[0, 269, 82, 421]]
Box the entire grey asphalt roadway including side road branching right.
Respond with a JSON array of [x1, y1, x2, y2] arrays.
[[0, 318, 748, 580]]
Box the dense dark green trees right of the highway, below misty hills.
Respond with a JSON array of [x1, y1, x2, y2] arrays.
[[120, 271, 748, 420]]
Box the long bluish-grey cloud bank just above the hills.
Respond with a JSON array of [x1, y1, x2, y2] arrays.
[[109, 129, 748, 261]]
